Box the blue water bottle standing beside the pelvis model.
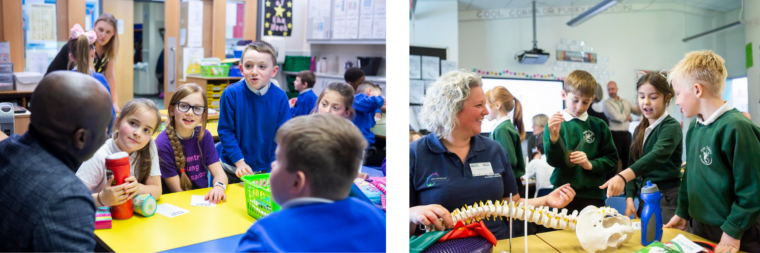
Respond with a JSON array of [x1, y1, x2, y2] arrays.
[[641, 181, 662, 246]]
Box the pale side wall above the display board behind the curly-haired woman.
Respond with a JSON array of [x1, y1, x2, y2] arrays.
[[410, 0, 463, 61]]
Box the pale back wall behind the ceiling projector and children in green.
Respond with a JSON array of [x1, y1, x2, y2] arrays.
[[459, 4, 745, 121]]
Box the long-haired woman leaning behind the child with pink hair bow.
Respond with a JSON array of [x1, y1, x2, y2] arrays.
[[45, 13, 121, 112]]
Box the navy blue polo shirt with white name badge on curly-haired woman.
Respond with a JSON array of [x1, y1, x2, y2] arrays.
[[409, 134, 517, 240]]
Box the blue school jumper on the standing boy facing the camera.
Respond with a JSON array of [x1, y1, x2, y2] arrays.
[[218, 79, 290, 171]]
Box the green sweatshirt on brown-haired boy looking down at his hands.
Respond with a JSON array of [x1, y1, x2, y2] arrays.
[[544, 116, 618, 200]]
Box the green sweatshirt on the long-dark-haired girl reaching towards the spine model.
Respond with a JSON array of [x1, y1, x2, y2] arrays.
[[625, 115, 683, 197]]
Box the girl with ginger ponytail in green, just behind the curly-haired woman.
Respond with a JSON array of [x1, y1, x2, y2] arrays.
[[486, 86, 527, 199]]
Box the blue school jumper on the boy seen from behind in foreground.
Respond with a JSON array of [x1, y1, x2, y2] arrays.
[[237, 198, 385, 252]]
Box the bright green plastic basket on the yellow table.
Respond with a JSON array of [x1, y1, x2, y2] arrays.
[[241, 173, 280, 219]]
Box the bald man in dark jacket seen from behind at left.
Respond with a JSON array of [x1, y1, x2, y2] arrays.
[[0, 71, 111, 252]]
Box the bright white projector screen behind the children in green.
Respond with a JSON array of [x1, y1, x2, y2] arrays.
[[480, 77, 564, 133]]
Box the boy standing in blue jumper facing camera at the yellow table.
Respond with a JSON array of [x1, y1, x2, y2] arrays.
[[219, 41, 291, 184]]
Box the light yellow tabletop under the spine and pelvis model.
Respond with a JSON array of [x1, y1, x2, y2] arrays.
[[532, 224, 744, 253]]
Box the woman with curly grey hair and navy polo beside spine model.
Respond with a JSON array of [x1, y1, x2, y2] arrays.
[[409, 71, 575, 240]]
